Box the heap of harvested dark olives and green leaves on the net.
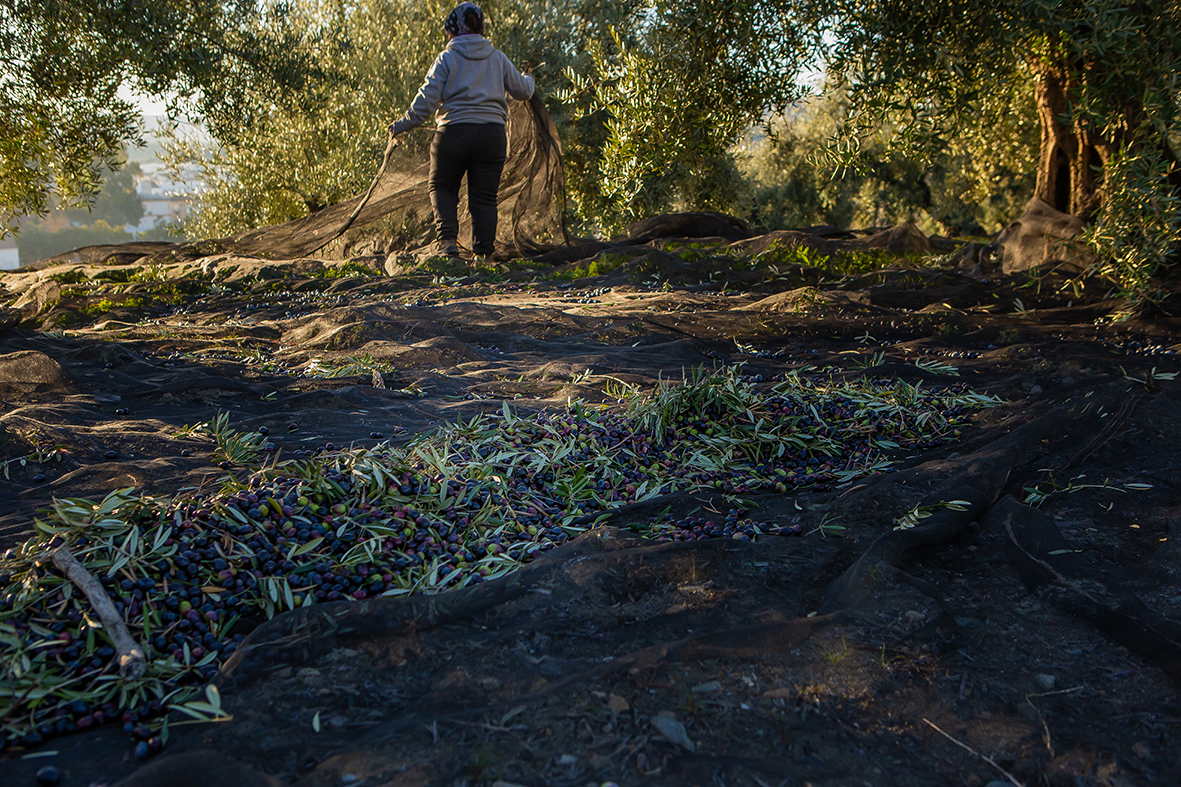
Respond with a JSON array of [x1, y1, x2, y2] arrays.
[[0, 372, 998, 753]]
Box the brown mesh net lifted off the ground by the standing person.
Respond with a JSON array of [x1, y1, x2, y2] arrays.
[[205, 95, 567, 259]]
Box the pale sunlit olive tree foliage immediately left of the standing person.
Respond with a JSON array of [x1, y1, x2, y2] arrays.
[[171, 0, 451, 238]]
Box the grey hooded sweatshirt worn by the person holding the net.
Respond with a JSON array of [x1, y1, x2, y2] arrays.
[[393, 33, 534, 134]]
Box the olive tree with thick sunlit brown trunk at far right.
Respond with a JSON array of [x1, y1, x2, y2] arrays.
[[815, 0, 1181, 299]]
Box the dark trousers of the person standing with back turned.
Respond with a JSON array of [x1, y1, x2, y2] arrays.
[[430, 123, 508, 254]]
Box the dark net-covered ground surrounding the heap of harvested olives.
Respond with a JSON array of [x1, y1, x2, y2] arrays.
[[0, 237, 1181, 787]]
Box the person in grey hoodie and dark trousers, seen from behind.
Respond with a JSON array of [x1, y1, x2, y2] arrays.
[[390, 2, 534, 256]]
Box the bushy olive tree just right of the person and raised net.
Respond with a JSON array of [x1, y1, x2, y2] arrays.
[[561, 0, 820, 229]]
